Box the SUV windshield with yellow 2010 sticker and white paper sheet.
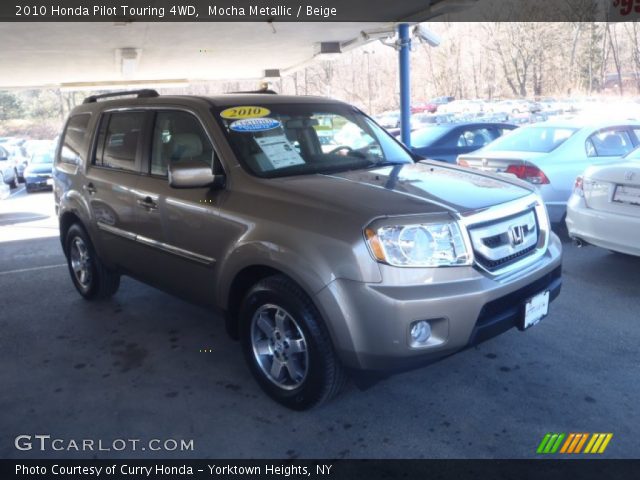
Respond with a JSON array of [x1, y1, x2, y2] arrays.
[[216, 104, 413, 178]]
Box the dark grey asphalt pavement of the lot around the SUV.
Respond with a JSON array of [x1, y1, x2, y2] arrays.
[[0, 187, 640, 459]]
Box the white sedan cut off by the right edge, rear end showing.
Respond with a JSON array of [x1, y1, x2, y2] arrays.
[[567, 149, 640, 256]]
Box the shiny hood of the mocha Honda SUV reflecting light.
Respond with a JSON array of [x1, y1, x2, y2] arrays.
[[268, 161, 533, 216]]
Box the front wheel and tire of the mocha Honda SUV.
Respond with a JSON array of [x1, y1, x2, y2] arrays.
[[239, 275, 346, 410]]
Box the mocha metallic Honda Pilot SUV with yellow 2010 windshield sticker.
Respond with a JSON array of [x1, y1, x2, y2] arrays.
[[54, 90, 561, 410]]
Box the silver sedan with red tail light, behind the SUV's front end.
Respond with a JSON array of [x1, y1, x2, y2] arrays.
[[458, 120, 640, 223]]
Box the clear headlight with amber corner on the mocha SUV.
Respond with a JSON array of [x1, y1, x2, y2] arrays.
[[365, 222, 471, 267]]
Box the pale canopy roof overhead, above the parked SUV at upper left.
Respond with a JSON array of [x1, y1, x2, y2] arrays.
[[0, 0, 470, 88]]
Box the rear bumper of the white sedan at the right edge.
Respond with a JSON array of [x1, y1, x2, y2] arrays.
[[567, 195, 640, 256]]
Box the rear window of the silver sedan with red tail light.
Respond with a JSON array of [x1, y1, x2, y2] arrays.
[[483, 126, 578, 153]]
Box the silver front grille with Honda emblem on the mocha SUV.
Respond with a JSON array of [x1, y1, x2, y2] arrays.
[[469, 209, 540, 272]]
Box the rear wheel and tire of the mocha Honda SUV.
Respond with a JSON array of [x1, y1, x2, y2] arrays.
[[65, 223, 120, 300]]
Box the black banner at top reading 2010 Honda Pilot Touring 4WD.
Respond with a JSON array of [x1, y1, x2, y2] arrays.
[[0, 0, 640, 22]]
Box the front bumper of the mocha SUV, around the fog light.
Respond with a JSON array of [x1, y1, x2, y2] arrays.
[[316, 235, 562, 371]]
